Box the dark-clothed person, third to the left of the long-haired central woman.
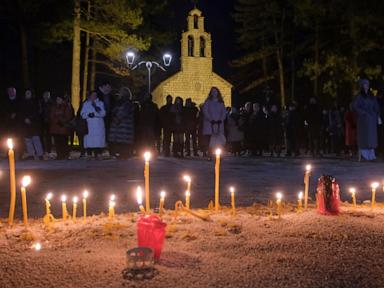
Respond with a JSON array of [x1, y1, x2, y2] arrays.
[[159, 95, 173, 157]]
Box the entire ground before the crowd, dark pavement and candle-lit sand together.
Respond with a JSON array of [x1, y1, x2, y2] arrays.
[[0, 157, 384, 288]]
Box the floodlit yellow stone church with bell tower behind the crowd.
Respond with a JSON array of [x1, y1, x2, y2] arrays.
[[152, 8, 232, 106]]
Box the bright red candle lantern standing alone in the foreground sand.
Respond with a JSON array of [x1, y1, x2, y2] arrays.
[[137, 215, 167, 260]]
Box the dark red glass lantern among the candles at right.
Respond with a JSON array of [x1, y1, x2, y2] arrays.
[[316, 176, 340, 215]]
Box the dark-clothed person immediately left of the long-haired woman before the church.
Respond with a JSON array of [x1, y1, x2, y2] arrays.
[[184, 98, 199, 156]]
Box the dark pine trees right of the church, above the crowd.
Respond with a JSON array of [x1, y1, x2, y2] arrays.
[[233, 0, 384, 106]]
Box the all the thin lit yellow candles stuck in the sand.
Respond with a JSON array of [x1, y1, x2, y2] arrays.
[[7, 139, 384, 225]]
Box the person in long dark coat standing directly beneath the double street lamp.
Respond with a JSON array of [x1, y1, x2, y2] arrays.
[[139, 95, 160, 152]]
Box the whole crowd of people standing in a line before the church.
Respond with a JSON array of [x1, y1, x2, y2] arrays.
[[0, 79, 384, 160]]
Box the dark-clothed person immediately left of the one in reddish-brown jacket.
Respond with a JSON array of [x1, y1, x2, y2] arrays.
[[40, 91, 52, 153]]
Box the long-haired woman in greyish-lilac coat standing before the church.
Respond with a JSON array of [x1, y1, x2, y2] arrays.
[[202, 87, 227, 152]]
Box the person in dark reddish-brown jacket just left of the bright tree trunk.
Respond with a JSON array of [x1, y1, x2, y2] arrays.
[[49, 96, 74, 160]]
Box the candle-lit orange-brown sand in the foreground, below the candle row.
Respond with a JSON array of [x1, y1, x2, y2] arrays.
[[0, 206, 384, 288]]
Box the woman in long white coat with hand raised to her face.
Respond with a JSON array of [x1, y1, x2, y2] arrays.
[[81, 91, 106, 156]]
